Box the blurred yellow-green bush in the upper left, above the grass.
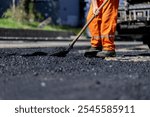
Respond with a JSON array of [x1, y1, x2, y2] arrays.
[[3, 0, 38, 22]]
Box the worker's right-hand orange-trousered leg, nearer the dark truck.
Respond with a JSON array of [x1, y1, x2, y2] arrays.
[[101, 0, 119, 51]]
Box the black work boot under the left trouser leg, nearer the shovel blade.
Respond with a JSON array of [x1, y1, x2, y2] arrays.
[[84, 46, 102, 57]]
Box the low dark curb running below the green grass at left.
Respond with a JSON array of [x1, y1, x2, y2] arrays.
[[0, 28, 75, 40]]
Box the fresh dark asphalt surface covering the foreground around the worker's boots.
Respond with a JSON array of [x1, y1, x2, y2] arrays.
[[0, 45, 150, 100]]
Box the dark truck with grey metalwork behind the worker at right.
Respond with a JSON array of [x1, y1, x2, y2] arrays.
[[117, 0, 150, 47]]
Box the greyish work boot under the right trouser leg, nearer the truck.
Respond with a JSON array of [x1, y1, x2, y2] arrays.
[[96, 50, 116, 58]]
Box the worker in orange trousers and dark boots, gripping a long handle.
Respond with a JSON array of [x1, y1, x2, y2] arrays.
[[85, 0, 119, 58]]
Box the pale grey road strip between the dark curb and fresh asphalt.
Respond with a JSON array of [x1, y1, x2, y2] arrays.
[[0, 40, 143, 48]]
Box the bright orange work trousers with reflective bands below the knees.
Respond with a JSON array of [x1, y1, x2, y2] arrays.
[[87, 0, 119, 51]]
